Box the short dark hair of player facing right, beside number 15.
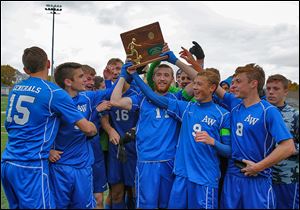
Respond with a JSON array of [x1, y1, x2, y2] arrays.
[[54, 62, 82, 89]]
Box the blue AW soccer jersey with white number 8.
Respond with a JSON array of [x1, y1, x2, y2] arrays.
[[224, 98, 292, 177]]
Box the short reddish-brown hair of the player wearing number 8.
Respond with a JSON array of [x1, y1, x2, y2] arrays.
[[235, 63, 265, 92]]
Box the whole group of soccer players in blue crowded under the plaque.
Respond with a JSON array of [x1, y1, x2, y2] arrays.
[[1, 42, 299, 209]]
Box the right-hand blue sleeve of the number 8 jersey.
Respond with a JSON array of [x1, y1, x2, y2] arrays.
[[266, 106, 293, 143]]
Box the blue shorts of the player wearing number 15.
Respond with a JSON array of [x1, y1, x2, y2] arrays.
[[1, 160, 56, 209]]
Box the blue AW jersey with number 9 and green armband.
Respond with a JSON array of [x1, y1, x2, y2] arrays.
[[168, 100, 230, 188]]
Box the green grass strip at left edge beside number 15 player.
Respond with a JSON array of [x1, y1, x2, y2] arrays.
[[1, 96, 8, 209]]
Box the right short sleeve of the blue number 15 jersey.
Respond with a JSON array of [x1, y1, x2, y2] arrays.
[[50, 89, 84, 123]]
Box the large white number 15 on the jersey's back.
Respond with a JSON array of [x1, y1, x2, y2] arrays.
[[6, 94, 35, 125]]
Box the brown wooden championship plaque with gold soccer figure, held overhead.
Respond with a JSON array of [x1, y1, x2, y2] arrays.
[[120, 22, 167, 74]]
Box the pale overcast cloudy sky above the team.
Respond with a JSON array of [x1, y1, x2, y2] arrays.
[[1, 1, 299, 83]]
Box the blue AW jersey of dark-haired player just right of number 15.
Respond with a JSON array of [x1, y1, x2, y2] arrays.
[[53, 90, 107, 168]]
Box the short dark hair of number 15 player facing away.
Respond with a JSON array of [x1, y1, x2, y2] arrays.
[[22, 46, 48, 73]]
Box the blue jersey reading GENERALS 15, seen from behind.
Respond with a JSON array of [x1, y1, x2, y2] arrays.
[[2, 77, 83, 161]]
